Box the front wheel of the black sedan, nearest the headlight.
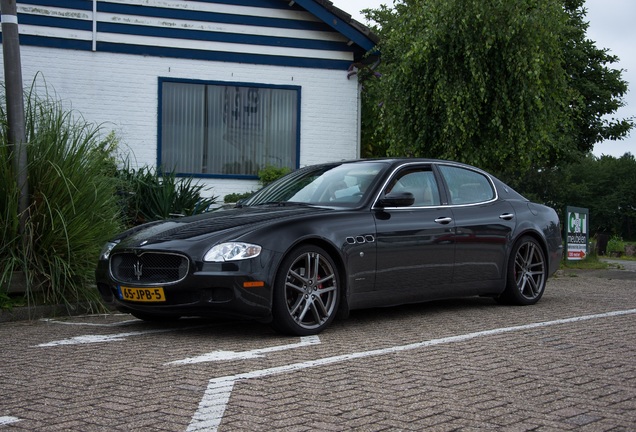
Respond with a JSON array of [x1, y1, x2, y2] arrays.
[[272, 245, 340, 336]]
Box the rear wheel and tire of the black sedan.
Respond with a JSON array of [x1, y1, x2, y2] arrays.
[[498, 236, 548, 306]]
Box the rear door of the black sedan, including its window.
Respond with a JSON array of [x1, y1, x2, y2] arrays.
[[438, 164, 516, 288]]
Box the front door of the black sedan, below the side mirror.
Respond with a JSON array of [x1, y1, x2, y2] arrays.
[[374, 165, 455, 300]]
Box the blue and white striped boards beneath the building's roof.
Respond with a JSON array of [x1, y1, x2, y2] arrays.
[[2, 0, 372, 69]]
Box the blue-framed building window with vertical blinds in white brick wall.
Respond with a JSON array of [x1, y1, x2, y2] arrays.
[[159, 80, 300, 177]]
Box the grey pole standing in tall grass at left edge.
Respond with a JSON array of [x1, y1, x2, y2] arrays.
[[0, 0, 29, 236]]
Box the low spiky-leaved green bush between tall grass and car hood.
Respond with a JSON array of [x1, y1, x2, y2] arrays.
[[116, 163, 217, 227]]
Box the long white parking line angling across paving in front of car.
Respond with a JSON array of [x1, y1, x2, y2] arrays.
[[187, 309, 636, 432]]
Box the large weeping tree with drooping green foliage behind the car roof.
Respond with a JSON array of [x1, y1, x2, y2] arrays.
[[366, 0, 569, 177]]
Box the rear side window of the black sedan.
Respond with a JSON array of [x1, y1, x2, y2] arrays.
[[439, 165, 495, 204]]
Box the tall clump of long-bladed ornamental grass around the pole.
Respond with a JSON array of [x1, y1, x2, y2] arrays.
[[0, 86, 122, 307]]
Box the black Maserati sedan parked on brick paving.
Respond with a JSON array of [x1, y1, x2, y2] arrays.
[[96, 159, 562, 335]]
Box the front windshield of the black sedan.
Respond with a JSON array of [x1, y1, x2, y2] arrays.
[[243, 161, 387, 207]]
